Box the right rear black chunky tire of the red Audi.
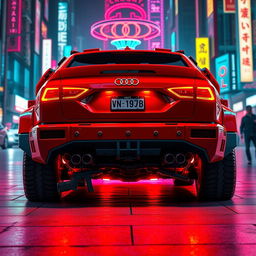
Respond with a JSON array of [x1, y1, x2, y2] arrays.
[[196, 150, 236, 201]]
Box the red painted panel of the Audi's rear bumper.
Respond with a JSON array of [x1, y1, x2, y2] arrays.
[[29, 123, 226, 163]]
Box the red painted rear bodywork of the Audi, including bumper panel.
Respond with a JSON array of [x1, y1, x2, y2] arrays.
[[19, 51, 236, 170]]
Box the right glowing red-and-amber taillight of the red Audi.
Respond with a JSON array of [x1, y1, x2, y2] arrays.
[[168, 86, 215, 101]]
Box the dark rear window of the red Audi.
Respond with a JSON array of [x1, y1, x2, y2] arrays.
[[68, 52, 188, 67]]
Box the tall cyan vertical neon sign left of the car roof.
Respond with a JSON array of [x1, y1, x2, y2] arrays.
[[58, 2, 68, 59]]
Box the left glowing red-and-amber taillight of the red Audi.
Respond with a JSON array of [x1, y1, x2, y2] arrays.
[[41, 87, 89, 101]]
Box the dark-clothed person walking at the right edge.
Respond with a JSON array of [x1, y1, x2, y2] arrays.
[[240, 105, 256, 165]]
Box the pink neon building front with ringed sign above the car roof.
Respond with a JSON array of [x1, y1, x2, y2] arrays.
[[91, 0, 164, 49]]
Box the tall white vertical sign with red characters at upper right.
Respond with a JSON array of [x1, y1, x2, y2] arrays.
[[238, 0, 253, 82]]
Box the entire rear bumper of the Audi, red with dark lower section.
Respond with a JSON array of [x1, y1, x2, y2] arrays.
[[20, 123, 227, 163]]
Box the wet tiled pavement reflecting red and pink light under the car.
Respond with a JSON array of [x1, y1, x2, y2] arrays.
[[0, 147, 256, 256]]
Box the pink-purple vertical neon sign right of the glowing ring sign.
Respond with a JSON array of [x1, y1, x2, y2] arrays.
[[148, 0, 164, 49]]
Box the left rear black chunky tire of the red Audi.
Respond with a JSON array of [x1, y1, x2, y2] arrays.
[[23, 153, 60, 202]]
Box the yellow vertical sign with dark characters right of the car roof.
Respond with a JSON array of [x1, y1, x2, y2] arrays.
[[196, 37, 210, 69]]
